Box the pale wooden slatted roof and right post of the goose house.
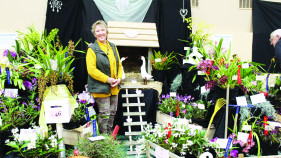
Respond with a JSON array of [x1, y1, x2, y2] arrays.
[[108, 21, 159, 74]]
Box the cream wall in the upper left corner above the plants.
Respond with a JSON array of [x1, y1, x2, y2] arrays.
[[0, 0, 48, 54]]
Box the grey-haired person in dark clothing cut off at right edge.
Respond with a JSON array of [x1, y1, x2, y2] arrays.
[[269, 29, 281, 67]]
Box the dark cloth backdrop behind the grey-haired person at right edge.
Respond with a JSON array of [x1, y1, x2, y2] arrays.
[[252, 0, 281, 72]]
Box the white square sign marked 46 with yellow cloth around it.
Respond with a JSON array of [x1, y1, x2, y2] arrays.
[[44, 99, 71, 123]]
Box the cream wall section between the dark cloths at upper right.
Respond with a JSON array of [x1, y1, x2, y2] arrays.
[[191, 0, 253, 61]]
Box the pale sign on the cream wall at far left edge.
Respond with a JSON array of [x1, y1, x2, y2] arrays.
[[0, 33, 17, 49]]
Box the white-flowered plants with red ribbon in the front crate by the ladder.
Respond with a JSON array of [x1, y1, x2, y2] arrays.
[[139, 122, 212, 157]]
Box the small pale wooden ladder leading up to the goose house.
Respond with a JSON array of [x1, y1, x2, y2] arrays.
[[122, 87, 147, 155]]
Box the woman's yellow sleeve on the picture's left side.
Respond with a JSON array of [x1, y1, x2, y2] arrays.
[[86, 48, 109, 83]]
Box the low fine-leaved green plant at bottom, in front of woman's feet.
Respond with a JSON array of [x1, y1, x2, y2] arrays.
[[69, 135, 126, 158]]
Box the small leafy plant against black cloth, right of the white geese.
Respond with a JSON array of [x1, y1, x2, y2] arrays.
[[149, 51, 179, 70]]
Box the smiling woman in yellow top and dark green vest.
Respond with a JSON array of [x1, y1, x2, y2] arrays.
[[86, 20, 122, 133]]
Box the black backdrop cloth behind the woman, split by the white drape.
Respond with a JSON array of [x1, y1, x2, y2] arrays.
[[45, 0, 191, 92]]
